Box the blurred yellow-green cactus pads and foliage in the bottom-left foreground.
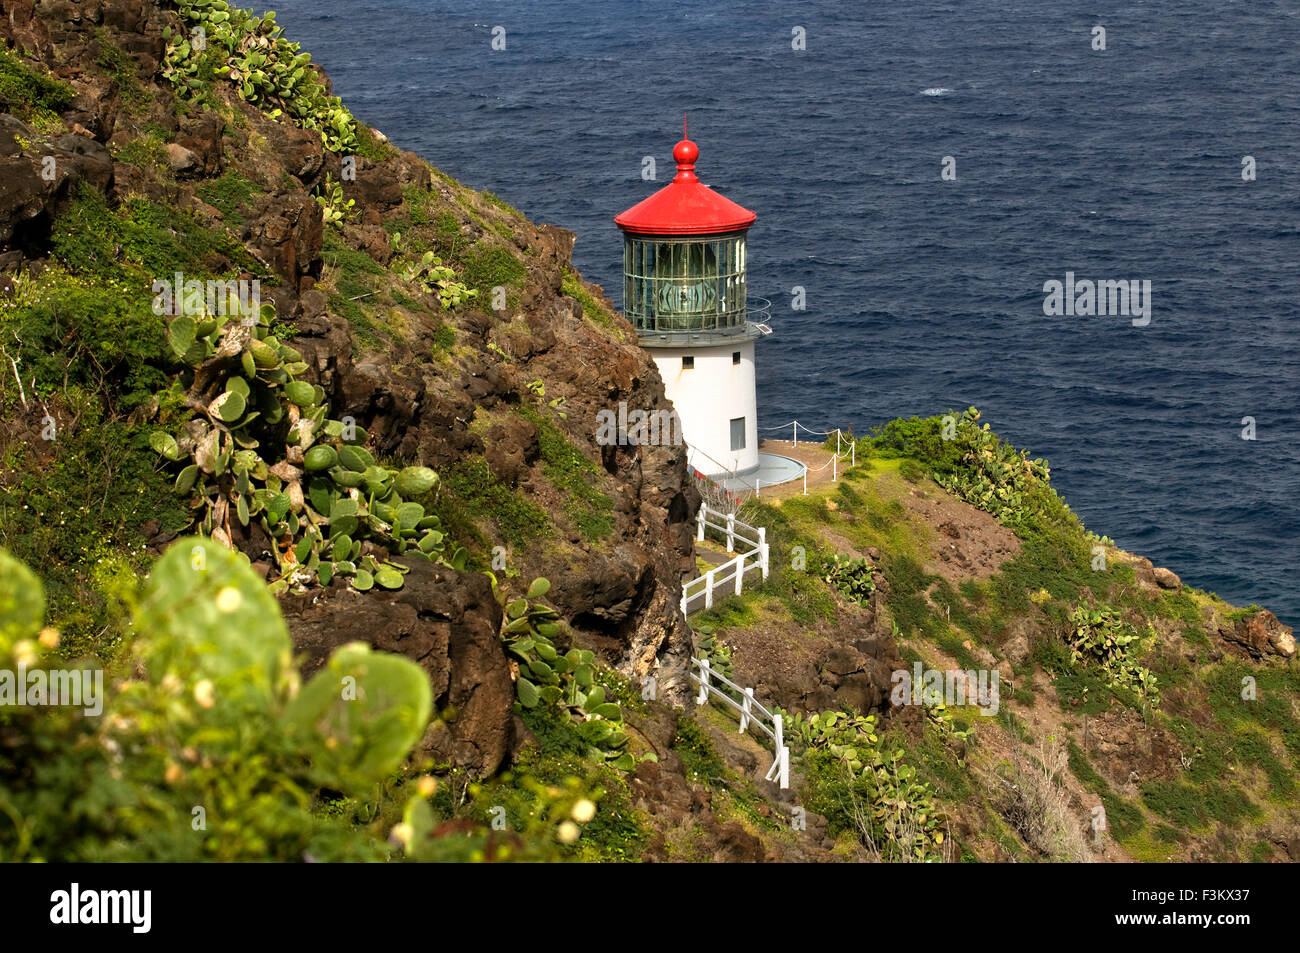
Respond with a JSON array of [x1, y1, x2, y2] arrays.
[[0, 538, 432, 861]]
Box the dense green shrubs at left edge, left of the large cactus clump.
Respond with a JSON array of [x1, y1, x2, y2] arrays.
[[0, 189, 267, 658]]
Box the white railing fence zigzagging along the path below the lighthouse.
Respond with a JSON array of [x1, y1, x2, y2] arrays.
[[681, 503, 790, 790]]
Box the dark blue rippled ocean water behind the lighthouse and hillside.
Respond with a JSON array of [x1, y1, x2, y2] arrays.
[[269, 0, 1300, 624]]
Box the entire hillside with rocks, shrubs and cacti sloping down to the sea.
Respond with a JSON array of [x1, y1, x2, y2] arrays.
[[0, 0, 1300, 861]]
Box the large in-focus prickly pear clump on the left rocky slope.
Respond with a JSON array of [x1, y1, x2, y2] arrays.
[[150, 299, 467, 592]]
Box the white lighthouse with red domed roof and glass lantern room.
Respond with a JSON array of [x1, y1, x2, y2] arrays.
[[614, 130, 771, 482]]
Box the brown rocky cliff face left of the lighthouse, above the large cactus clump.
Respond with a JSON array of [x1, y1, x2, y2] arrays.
[[0, 0, 697, 785]]
